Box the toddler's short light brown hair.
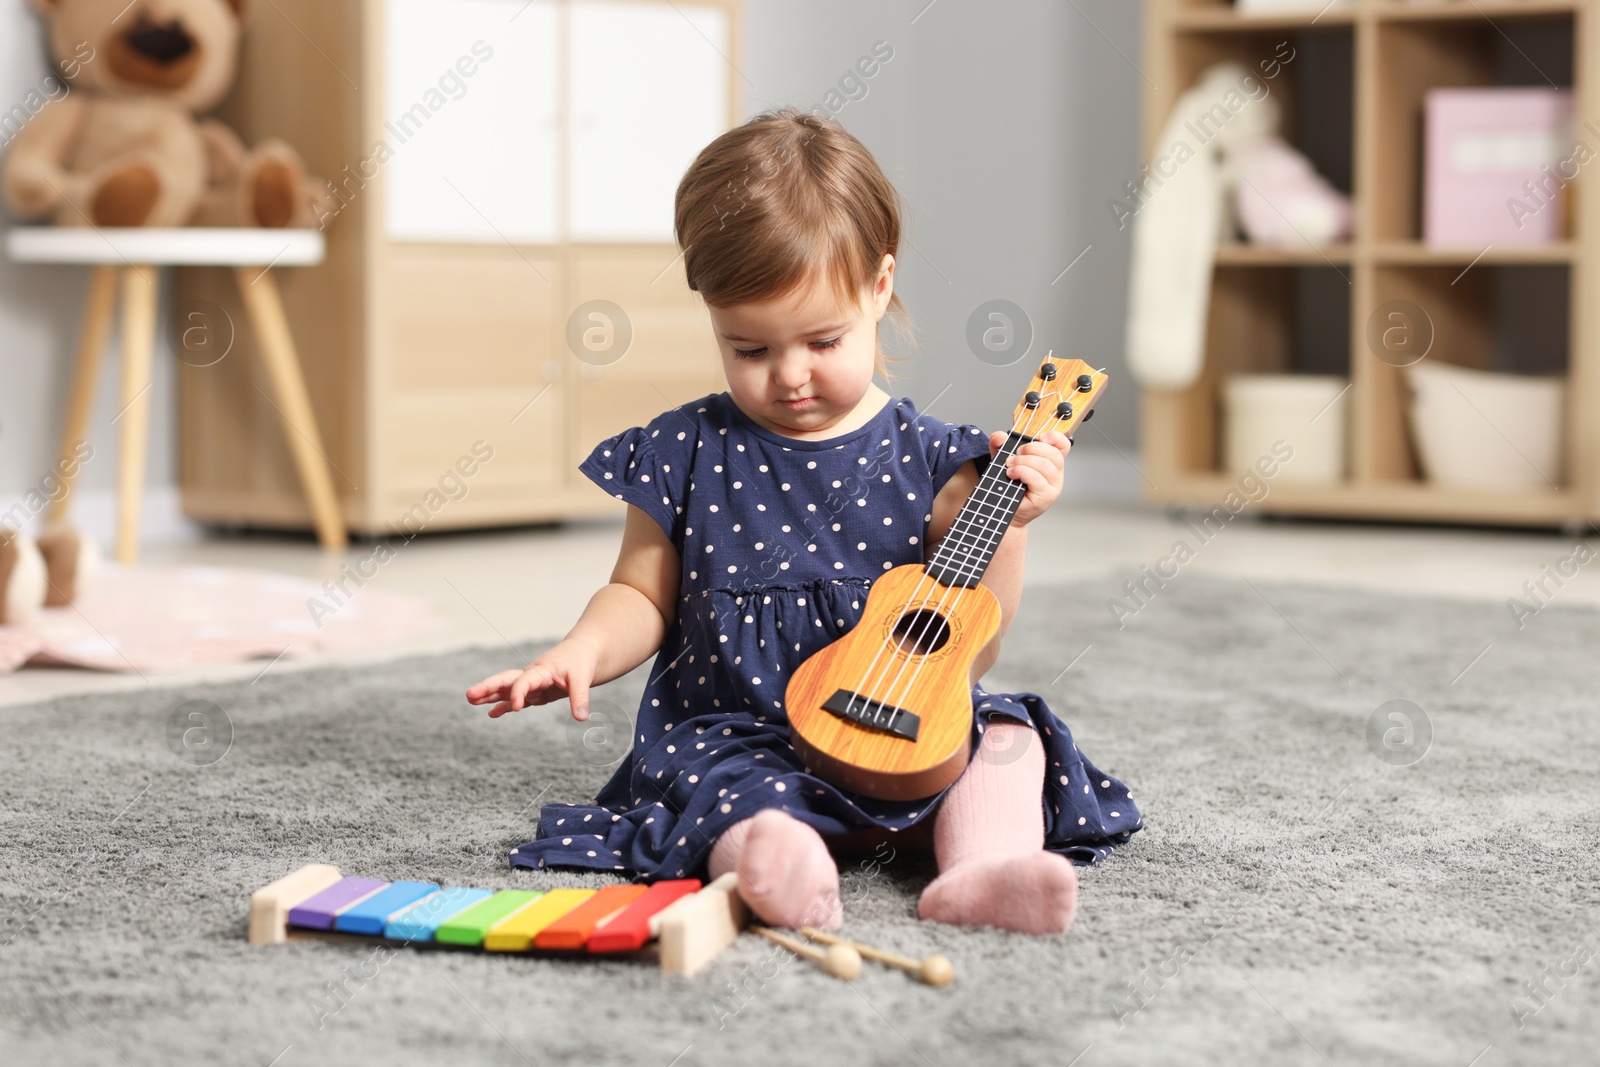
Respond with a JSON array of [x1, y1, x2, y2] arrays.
[[674, 107, 910, 379]]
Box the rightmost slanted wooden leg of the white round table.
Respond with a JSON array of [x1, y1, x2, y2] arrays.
[[234, 267, 347, 549]]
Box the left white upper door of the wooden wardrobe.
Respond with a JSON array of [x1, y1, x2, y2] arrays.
[[381, 0, 558, 245]]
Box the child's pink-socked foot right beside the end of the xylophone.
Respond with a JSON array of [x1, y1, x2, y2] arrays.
[[707, 808, 845, 929]]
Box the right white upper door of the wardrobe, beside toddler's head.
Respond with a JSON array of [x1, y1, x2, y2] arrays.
[[570, 0, 730, 242]]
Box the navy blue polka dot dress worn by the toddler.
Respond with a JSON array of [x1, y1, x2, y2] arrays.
[[510, 394, 1142, 881]]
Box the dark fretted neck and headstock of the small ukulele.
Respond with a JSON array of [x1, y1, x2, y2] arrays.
[[923, 360, 1106, 587]]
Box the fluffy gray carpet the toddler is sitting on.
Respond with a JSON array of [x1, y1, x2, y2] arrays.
[[0, 576, 1600, 1067]]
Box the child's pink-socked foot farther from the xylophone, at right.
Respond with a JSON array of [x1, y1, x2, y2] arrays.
[[917, 849, 1078, 934]]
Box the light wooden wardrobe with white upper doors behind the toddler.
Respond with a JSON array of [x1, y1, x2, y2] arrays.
[[174, 0, 741, 536]]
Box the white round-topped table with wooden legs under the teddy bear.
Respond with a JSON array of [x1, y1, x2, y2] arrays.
[[6, 226, 347, 563]]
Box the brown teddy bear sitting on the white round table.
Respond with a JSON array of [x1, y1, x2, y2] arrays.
[[0, 0, 331, 227]]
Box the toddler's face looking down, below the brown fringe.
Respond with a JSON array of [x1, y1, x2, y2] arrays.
[[709, 256, 894, 437]]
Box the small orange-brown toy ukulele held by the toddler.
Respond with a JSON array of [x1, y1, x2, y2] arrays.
[[786, 360, 1106, 800]]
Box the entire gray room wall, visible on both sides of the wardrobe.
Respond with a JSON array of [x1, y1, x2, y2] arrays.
[[0, 0, 1144, 541]]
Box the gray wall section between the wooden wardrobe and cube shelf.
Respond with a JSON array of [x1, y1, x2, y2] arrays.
[[744, 0, 1144, 460]]
